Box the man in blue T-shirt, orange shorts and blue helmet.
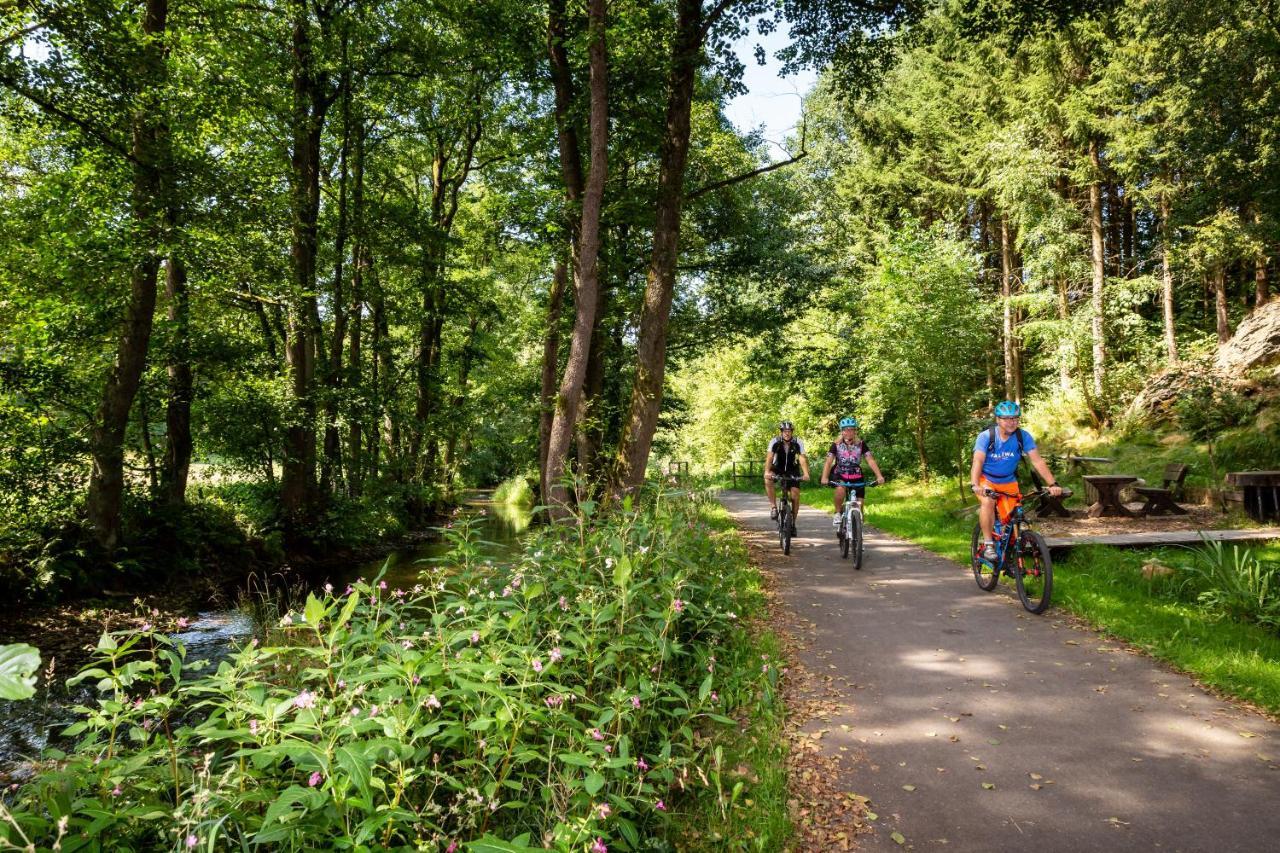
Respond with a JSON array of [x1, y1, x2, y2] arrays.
[[969, 400, 1062, 560]]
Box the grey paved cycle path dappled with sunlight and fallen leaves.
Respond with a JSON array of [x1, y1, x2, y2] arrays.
[[721, 492, 1280, 853]]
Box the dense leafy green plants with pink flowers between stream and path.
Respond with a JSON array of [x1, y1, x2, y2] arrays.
[[0, 489, 777, 850]]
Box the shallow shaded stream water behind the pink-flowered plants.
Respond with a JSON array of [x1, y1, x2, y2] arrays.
[[0, 501, 531, 784]]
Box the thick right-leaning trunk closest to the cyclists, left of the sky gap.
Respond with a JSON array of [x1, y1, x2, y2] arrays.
[[613, 0, 701, 493]]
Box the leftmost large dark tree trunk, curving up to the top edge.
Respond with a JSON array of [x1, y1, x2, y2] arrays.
[[84, 0, 169, 551]]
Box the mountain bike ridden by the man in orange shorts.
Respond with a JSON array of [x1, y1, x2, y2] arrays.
[[969, 489, 1071, 613]]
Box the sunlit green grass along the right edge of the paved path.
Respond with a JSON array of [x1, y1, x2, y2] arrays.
[[721, 478, 1280, 713]]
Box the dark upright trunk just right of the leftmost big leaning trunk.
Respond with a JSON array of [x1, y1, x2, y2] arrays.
[[160, 255, 193, 506]]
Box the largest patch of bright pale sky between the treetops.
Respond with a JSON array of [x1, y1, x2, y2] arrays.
[[724, 26, 818, 160]]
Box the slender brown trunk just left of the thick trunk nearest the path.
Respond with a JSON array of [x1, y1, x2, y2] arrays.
[[543, 0, 609, 517]]
